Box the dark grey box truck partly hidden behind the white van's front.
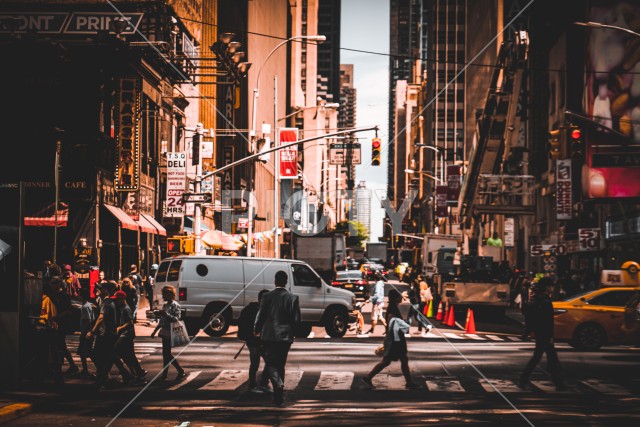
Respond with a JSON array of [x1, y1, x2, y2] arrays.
[[292, 233, 347, 283]]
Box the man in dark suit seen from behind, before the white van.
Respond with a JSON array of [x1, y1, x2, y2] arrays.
[[253, 271, 300, 406]]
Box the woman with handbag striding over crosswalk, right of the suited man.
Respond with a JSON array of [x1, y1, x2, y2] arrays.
[[362, 289, 420, 390]]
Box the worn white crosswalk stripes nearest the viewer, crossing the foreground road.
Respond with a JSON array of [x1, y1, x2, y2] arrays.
[[142, 369, 633, 396]]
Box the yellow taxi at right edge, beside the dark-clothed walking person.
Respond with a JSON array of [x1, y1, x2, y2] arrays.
[[553, 286, 640, 350]]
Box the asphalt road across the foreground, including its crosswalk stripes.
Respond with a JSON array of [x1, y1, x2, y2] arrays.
[[6, 326, 640, 427]]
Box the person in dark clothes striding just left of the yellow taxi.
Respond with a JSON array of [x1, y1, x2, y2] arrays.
[[519, 277, 567, 391]]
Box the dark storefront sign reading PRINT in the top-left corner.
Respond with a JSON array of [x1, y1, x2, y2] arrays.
[[0, 12, 144, 34]]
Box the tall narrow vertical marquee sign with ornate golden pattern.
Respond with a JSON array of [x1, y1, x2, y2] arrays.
[[114, 77, 140, 191]]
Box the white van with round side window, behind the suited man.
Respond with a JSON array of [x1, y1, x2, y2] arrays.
[[147, 255, 356, 338]]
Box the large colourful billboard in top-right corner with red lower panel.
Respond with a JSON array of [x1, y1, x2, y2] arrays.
[[582, 0, 640, 199]]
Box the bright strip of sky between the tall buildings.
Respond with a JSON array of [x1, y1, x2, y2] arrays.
[[340, 0, 390, 242]]
